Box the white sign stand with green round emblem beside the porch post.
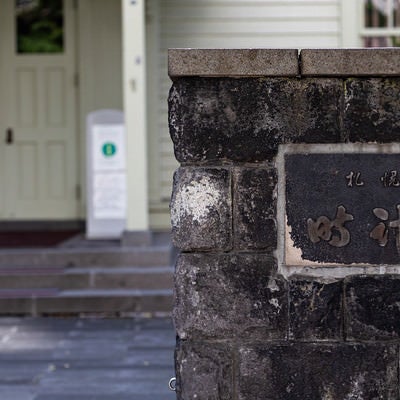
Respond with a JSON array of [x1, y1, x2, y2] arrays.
[[86, 110, 127, 239]]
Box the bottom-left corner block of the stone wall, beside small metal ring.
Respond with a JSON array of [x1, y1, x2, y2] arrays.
[[175, 341, 233, 400]]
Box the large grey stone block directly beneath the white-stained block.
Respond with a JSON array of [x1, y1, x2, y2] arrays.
[[173, 254, 287, 339]]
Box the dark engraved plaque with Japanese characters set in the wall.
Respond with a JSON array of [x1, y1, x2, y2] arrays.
[[283, 146, 400, 265]]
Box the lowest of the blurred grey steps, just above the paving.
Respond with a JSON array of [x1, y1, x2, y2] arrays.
[[0, 289, 173, 316]]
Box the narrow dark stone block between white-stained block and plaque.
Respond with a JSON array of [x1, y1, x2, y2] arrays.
[[233, 168, 277, 250]]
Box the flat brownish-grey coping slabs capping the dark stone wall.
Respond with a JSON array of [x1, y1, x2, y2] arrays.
[[168, 48, 400, 78]]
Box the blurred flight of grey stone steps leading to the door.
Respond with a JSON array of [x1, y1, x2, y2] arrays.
[[0, 233, 173, 315]]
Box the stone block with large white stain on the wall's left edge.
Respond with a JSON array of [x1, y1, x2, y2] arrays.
[[171, 167, 232, 250]]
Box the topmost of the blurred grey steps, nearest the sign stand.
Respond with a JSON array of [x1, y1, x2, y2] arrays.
[[0, 245, 171, 267]]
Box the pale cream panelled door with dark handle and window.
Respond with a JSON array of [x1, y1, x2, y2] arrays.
[[0, 0, 79, 220]]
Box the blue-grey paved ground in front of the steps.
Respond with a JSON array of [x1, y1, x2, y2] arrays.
[[0, 318, 175, 400]]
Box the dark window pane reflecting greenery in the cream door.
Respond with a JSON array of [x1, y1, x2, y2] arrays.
[[15, 0, 64, 54]]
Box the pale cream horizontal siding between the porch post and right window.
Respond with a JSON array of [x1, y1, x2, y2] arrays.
[[153, 0, 341, 209]]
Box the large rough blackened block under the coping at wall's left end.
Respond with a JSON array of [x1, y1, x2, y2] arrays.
[[169, 78, 296, 162]]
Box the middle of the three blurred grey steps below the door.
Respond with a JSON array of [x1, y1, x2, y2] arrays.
[[0, 266, 174, 290]]
